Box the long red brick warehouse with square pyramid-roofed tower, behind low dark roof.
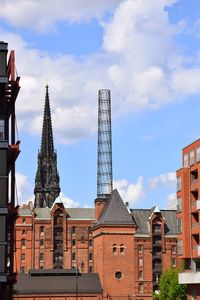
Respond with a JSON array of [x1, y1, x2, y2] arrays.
[[15, 190, 177, 300]]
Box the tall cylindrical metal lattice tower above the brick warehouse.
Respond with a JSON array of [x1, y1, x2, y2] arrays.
[[97, 89, 113, 198]]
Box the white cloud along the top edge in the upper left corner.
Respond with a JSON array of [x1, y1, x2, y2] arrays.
[[0, 0, 120, 32]]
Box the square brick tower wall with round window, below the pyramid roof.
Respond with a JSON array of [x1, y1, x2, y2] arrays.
[[93, 226, 135, 299]]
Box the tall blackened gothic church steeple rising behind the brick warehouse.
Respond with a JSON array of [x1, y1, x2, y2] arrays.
[[34, 86, 60, 207]]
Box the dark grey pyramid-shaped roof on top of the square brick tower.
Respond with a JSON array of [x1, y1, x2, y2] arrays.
[[96, 189, 134, 225]]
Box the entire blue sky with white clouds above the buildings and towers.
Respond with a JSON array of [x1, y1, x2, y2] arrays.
[[0, 0, 200, 208]]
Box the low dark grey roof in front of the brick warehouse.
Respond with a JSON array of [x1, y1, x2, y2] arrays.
[[14, 270, 102, 295]]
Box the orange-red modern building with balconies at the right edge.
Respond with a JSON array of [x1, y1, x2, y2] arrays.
[[177, 140, 200, 300]]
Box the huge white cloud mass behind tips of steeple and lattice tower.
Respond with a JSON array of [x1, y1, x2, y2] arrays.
[[0, 0, 200, 143]]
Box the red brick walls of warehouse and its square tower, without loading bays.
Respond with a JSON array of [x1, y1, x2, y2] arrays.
[[15, 203, 177, 300]]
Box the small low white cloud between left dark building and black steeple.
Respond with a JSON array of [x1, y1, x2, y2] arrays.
[[16, 172, 33, 204]]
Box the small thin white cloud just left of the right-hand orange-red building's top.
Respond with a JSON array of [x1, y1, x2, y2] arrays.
[[149, 172, 176, 189]]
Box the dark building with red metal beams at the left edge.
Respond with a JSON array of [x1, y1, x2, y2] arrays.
[[0, 42, 20, 300]]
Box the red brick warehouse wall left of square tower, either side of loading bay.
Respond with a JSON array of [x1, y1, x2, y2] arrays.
[[14, 209, 93, 273]]
